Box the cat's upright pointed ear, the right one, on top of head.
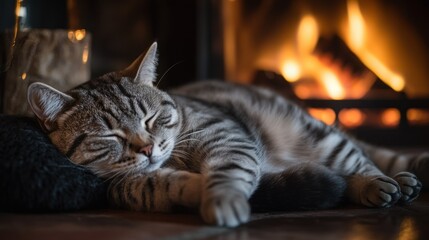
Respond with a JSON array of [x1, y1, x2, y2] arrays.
[[122, 42, 158, 86]]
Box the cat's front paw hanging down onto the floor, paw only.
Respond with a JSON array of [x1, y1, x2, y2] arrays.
[[201, 191, 250, 227]]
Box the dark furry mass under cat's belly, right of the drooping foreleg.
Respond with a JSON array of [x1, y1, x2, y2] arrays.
[[250, 164, 346, 212]]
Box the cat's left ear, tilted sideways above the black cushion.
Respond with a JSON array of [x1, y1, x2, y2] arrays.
[[27, 82, 74, 131]]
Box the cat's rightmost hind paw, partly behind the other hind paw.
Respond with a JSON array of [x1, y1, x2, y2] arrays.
[[393, 172, 422, 204]]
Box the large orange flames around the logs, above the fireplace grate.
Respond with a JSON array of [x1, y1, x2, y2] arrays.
[[278, 0, 405, 100]]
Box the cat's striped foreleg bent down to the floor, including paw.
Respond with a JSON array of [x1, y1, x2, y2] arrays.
[[200, 147, 260, 227]]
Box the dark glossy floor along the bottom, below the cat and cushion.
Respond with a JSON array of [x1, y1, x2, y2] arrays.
[[0, 193, 429, 240]]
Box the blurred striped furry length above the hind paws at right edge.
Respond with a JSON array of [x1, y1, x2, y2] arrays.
[[359, 143, 429, 190]]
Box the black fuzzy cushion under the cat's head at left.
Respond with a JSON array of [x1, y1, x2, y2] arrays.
[[0, 115, 107, 212]]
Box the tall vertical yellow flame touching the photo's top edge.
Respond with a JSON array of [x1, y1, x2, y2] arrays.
[[347, 0, 365, 49]]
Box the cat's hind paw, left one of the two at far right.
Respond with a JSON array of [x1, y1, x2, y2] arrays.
[[361, 176, 401, 207]]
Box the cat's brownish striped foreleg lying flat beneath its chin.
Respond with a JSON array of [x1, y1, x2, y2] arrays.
[[109, 168, 202, 212]]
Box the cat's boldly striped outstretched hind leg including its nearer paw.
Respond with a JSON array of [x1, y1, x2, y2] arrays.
[[308, 128, 401, 207]]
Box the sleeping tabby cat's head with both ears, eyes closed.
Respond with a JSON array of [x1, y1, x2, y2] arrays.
[[28, 43, 180, 177]]
